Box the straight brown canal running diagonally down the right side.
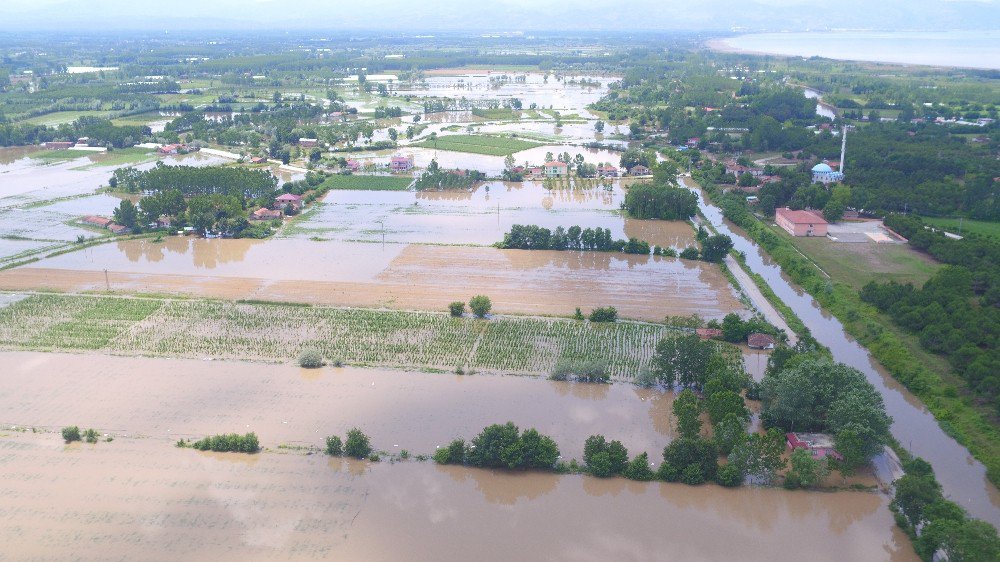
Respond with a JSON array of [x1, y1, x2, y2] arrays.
[[682, 178, 1000, 526]]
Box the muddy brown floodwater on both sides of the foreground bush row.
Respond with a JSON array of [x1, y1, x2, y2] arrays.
[[0, 353, 916, 561]]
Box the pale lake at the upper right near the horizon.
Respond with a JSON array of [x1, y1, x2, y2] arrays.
[[713, 31, 1000, 70]]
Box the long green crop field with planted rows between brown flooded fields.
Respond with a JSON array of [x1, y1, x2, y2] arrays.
[[0, 294, 679, 379]]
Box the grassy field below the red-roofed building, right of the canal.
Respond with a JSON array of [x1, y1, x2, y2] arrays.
[[771, 228, 940, 290]]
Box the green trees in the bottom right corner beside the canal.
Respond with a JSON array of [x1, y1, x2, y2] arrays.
[[889, 458, 1000, 560]]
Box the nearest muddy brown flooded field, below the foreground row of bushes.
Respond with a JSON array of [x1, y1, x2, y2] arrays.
[[0, 433, 915, 560]]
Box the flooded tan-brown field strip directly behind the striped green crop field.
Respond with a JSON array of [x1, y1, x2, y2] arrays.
[[0, 237, 745, 321]]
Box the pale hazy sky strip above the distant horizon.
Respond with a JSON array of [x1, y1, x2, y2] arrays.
[[0, 0, 1000, 32]]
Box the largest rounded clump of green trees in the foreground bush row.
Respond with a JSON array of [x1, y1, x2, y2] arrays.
[[434, 422, 559, 470]]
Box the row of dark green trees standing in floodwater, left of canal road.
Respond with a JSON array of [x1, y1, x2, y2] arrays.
[[498, 224, 650, 255]]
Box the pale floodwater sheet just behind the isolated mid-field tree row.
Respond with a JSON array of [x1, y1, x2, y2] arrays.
[[292, 182, 694, 250]]
